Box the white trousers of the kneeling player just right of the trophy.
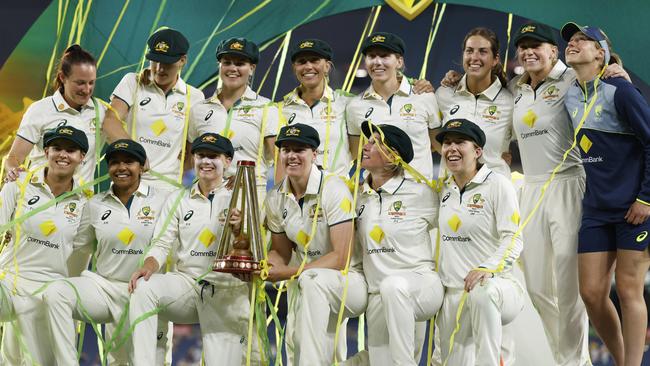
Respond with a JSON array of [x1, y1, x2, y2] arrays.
[[287, 268, 368, 366]]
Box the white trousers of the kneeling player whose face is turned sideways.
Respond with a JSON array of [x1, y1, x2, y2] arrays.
[[366, 272, 444, 366]]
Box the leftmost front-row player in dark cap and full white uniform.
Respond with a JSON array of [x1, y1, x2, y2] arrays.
[[0, 126, 88, 365]]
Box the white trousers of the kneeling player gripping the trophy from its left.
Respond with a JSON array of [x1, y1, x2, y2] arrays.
[[129, 272, 249, 366]]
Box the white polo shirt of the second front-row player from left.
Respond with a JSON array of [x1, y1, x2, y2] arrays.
[[74, 182, 167, 282]]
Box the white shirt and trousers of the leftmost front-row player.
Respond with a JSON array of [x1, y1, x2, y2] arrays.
[[0, 169, 88, 365]]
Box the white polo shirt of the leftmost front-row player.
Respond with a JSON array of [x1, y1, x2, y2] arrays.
[[0, 169, 88, 281]]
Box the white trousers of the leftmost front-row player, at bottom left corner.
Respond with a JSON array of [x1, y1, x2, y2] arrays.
[[0, 274, 54, 366]]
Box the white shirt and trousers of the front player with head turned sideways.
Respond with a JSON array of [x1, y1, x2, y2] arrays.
[[357, 175, 444, 366]]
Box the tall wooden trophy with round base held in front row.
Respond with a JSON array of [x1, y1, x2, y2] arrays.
[[212, 160, 264, 273]]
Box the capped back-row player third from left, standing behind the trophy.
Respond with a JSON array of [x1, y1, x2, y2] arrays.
[[190, 38, 281, 202]]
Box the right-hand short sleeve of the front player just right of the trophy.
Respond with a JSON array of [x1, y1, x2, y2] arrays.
[[321, 175, 355, 226]]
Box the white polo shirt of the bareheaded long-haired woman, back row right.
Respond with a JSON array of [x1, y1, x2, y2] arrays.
[[436, 75, 513, 177]]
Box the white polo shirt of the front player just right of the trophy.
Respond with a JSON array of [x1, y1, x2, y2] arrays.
[[265, 165, 361, 270]]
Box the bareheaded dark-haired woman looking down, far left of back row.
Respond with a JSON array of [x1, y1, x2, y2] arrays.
[[6, 44, 105, 184]]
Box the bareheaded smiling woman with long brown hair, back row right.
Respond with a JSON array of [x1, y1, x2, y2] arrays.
[[436, 28, 513, 178]]
